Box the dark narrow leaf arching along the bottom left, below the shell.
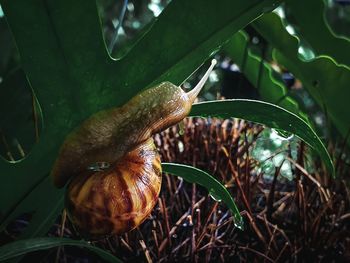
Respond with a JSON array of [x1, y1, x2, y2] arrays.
[[0, 237, 122, 263]]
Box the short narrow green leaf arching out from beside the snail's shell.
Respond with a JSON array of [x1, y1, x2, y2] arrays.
[[162, 163, 243, 229]]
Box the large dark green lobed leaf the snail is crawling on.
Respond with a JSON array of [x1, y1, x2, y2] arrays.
[[0, 0, 279, 237]]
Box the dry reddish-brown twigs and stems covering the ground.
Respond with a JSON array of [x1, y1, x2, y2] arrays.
[[52, 118, 350, 262]]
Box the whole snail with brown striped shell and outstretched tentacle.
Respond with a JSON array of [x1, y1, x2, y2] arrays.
[[51, 60, 216, 239]]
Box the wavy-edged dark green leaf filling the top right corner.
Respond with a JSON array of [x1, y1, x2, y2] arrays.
[[287, 0, 350, 66]]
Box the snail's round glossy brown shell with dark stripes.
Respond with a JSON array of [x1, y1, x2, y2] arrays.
[[65, 139, 162, 239]]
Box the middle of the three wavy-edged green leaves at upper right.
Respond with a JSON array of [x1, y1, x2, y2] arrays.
[[253, 13, 350, 148]]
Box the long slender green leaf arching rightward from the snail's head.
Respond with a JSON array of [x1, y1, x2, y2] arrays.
[[190, 100, 335, 176]]
